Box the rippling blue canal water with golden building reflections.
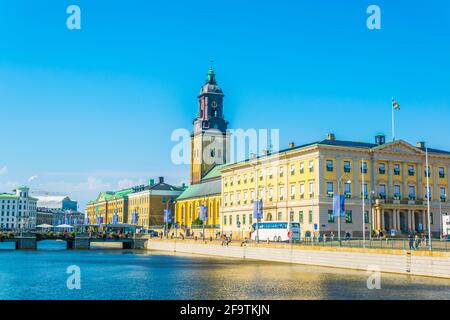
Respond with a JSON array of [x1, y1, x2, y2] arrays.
[[0, 241, 450, 300]]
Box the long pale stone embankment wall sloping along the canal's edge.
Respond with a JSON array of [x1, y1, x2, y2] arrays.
[[147, 239, 450, 278]]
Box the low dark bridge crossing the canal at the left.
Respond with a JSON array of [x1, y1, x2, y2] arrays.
[[0, 233, 150, 250]]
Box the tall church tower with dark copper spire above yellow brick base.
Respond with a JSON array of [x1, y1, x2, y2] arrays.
[[191, 67, 229, 184]]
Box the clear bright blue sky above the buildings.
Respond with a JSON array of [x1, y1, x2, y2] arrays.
[[0, 0, 450, 208]]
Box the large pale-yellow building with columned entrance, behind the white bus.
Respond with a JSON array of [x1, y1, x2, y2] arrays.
[[221, 134, 450, 240]]
